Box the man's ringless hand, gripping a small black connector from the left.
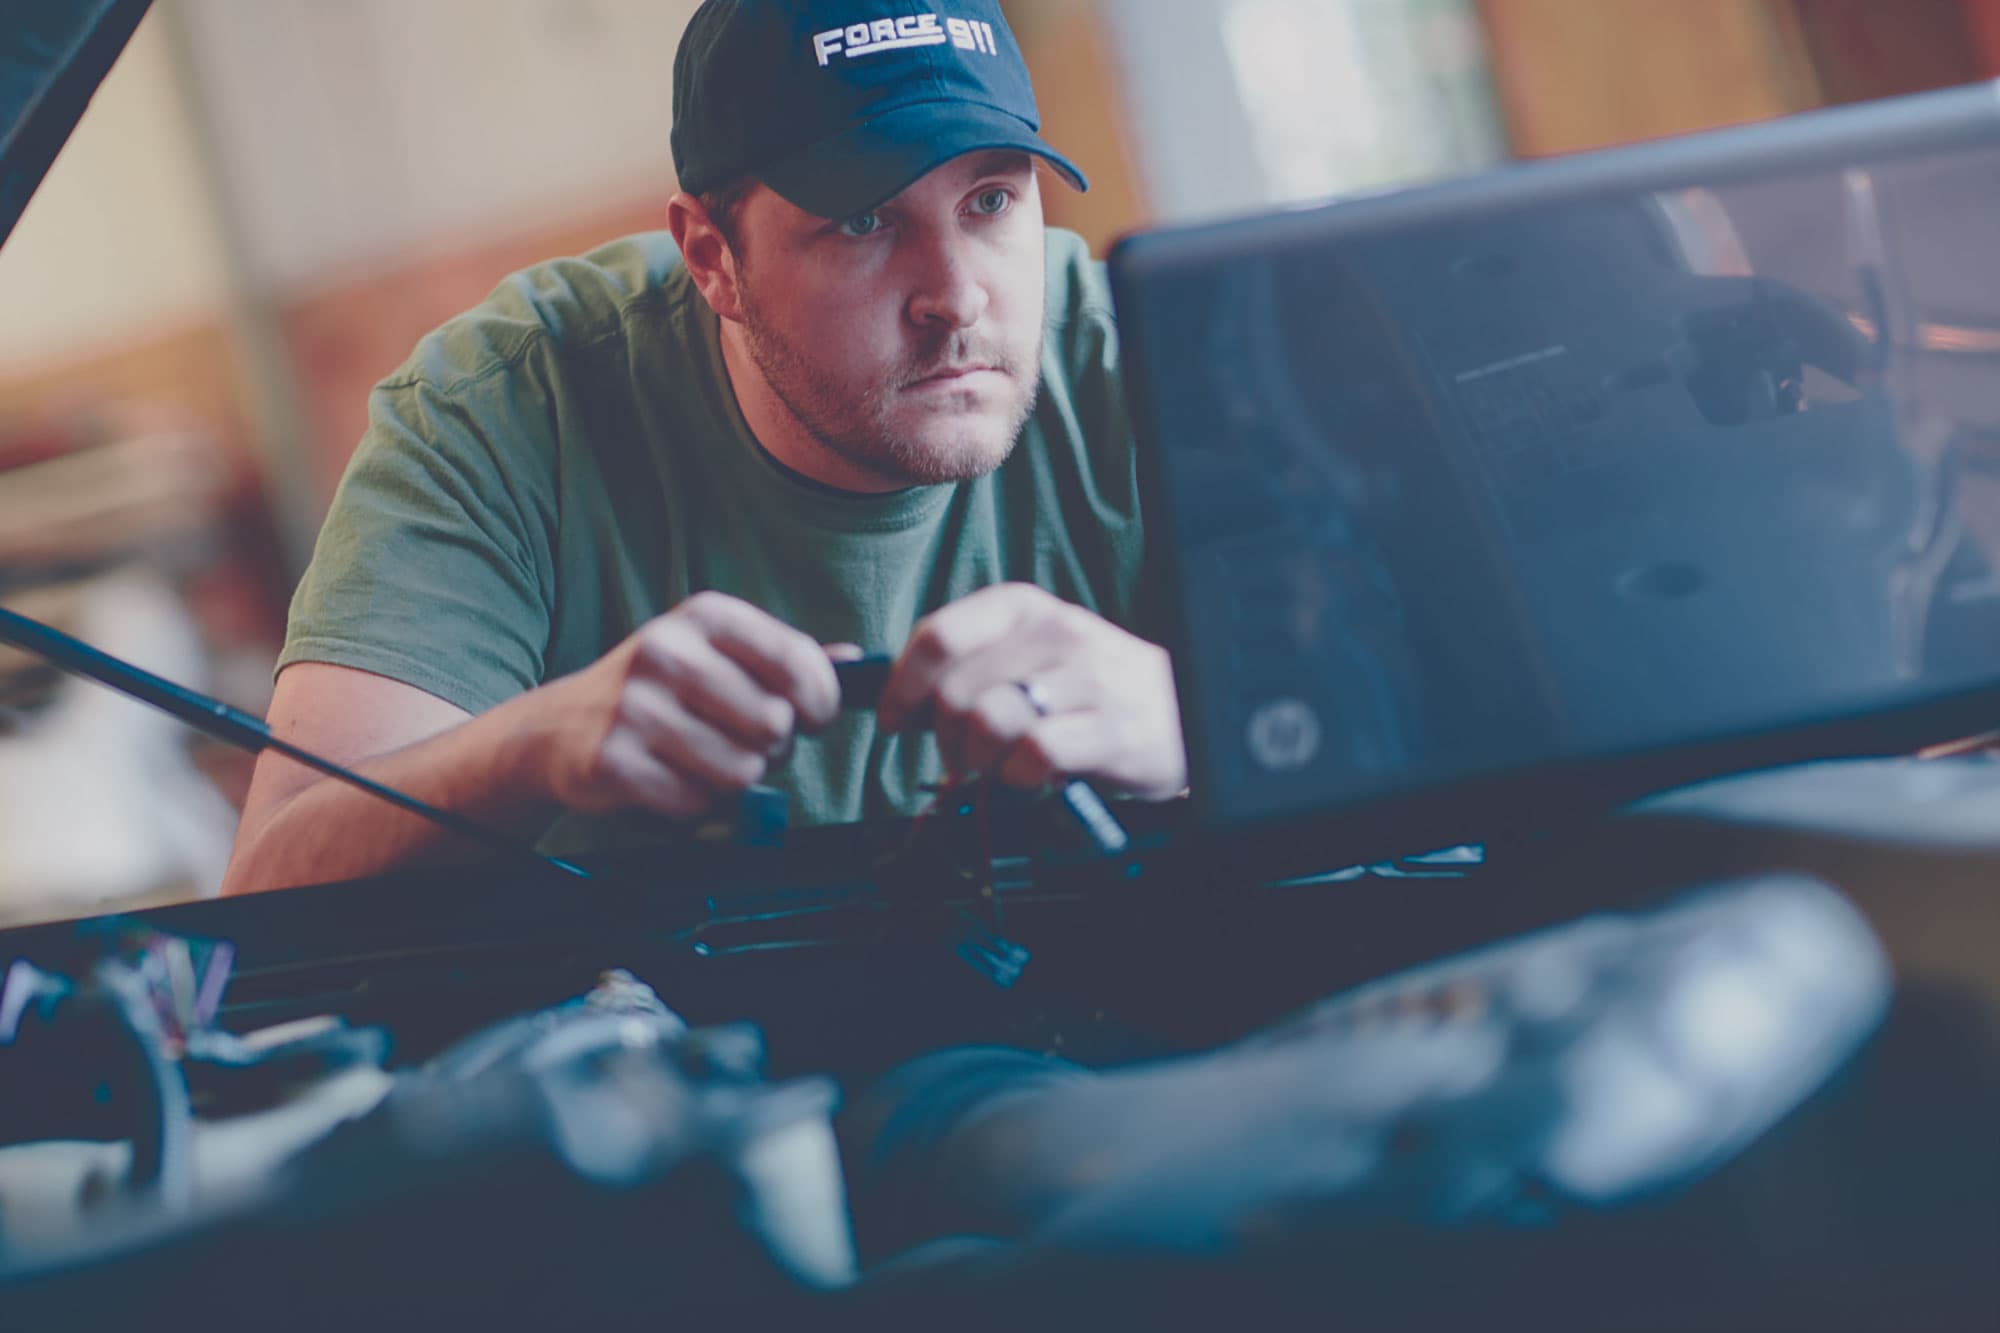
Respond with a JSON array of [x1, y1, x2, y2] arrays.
[[538, 592, 840, 817]]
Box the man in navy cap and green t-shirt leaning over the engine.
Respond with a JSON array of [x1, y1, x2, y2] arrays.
[[224, 0, 1186, 893]]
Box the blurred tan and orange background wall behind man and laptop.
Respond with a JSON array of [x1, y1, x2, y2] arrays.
[[0, 0, 2000, 919]]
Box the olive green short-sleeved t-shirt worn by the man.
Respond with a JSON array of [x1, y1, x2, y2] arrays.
[[278, 230, 1142, 849]]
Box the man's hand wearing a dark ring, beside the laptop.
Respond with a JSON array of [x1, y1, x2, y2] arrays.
[[876, 582, 1188, 799]]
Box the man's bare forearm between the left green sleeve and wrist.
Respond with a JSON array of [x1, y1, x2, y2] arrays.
[[222, 697, 556, 893]]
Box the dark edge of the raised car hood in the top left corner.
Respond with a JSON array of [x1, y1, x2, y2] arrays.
[[0, 0, 152, 244]]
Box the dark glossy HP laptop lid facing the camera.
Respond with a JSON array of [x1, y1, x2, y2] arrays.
[[1112, 88, 2000, 839]]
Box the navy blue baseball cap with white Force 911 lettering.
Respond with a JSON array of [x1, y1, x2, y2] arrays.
[[672, 0, 1090, 218]]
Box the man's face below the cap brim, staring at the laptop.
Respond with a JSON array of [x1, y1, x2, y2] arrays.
[[734, 152, 1044, 486]]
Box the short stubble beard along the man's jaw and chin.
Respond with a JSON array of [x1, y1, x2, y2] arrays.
[[742, 284, 1042, 486]]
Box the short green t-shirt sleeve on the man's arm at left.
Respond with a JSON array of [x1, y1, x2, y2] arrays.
[[278, 362, 556, 713]]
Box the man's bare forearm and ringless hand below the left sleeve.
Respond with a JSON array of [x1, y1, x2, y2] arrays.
[[222, 592, 840, 880]]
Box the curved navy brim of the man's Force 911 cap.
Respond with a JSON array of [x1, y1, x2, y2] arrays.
[[756, 102, 1090, 218]]
